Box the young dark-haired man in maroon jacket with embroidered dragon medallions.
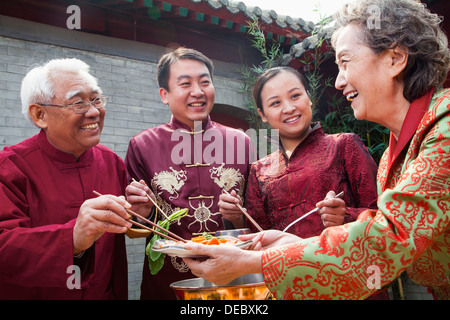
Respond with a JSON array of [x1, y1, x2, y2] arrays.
[[125, 48, 250, 299]]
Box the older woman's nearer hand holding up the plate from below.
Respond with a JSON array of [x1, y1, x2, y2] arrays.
[[183, 243, 262, 285]]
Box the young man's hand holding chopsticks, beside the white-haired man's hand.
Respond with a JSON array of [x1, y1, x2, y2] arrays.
[[125, 180, 156, 218]]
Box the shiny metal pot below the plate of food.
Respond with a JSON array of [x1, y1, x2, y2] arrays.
[[170, 273, 273, 300]]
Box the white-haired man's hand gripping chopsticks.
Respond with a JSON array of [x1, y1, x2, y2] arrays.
[[73, 195, 131, 254]]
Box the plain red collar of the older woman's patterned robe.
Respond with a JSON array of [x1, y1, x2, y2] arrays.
[[388, 90, 433, 172]]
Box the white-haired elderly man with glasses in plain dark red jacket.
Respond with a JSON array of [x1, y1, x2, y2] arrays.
[[0, 59, 131, 299]]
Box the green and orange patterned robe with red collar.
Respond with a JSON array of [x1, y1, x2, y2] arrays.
[[262, 90, 450, 299]]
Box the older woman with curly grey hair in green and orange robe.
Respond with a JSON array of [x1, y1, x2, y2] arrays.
[[184, 0, 450, 300]]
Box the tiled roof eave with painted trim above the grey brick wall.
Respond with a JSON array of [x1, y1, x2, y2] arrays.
[[0, 0, 324, 62]]
